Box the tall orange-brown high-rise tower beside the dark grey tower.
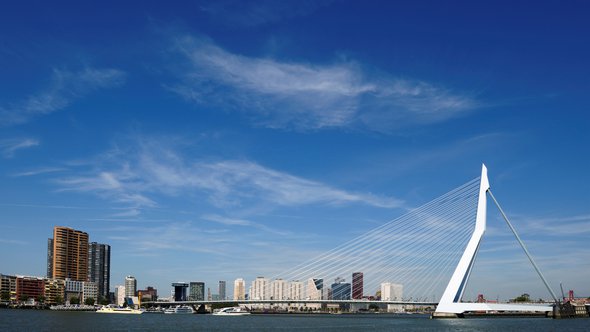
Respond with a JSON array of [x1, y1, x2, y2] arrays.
[[47, 226, 88, 281]]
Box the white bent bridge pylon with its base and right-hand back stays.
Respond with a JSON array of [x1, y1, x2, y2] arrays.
[[436, 165, 557, 316]]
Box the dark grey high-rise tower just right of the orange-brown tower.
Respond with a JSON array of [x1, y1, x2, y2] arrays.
[[88, 242, 111, 299]]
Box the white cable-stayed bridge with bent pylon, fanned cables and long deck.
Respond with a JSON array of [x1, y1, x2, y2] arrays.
[[150, 165, 557, 316]]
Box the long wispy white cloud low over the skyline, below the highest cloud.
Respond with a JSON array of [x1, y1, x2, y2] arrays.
[[57, 136, 403, 214]]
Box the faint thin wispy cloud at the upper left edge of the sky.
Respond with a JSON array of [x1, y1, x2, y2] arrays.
[[0, 67, 125, 126]]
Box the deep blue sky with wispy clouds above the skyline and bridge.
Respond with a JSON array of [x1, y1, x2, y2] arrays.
[[0, 0, 590, 299]]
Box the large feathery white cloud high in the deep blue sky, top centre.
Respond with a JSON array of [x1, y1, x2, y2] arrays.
[[168, 36, 477, 131]]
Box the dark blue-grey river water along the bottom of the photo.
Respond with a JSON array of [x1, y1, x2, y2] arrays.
[[0, 309, 590, 332]]
